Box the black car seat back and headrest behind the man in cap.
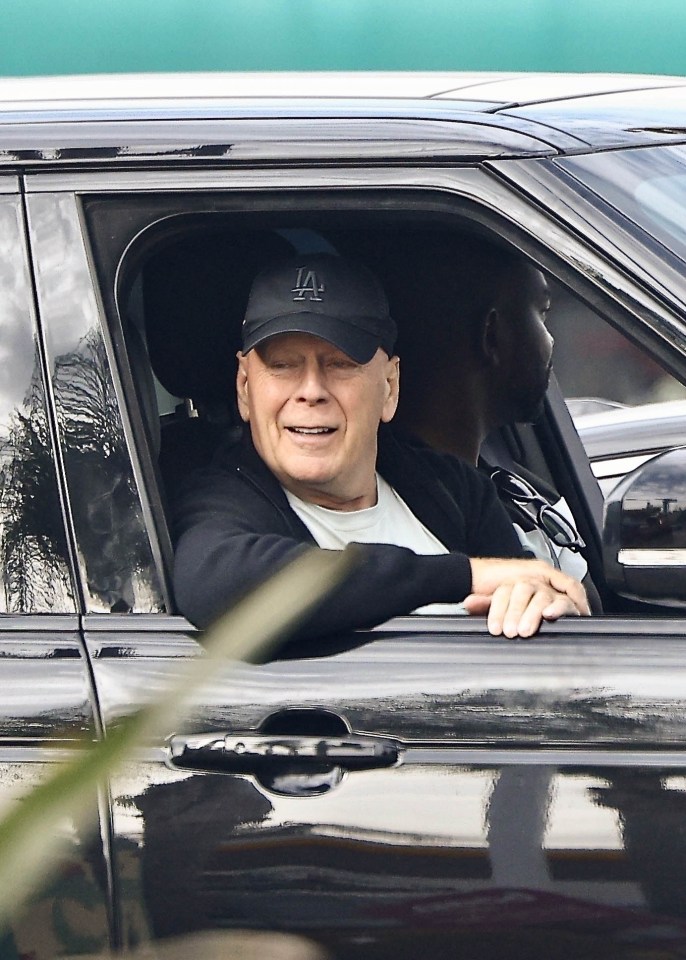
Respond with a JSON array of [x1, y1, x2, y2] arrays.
[[137, 230, 293, 501]]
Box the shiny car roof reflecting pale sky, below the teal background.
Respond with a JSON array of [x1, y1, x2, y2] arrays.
[[0, 72, 686, 165]]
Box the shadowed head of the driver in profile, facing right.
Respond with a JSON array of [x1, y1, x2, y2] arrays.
[[390, 231, 553, 450]]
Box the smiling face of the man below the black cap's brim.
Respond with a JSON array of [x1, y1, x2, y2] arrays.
[[236, 333, 398, 510]]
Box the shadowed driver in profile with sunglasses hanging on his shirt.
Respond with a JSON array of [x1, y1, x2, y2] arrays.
[[393, 232, 601, 611]]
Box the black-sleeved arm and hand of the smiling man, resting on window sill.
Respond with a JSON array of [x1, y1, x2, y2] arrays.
[[174, 471, 586, 638]]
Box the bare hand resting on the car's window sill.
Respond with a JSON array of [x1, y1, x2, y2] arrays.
[[464, 558, 591, 637]]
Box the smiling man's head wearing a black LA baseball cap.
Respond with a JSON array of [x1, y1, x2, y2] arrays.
[[236, 254, 398, 509]]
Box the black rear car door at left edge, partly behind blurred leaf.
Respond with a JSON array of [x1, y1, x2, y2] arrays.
[[0, 184, 111, 960]]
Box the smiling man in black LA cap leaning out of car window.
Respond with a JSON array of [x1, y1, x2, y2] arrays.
[[174, 254, 589, 637]]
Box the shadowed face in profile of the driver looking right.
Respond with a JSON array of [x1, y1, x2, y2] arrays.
[[502, 266, 553, 423]]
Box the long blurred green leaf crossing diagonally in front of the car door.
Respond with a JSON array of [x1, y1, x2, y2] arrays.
[[0, 549, 355, 926]]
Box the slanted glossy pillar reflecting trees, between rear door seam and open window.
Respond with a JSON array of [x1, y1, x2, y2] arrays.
[[28, 194, 169, 614]]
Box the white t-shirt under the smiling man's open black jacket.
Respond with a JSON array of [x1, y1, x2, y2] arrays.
[[284, 473, 466, 616]]
